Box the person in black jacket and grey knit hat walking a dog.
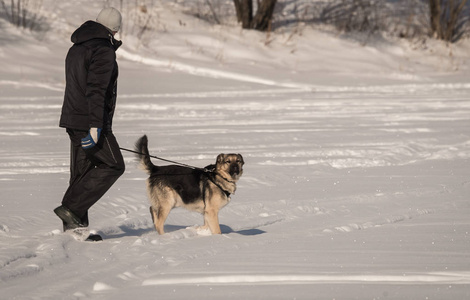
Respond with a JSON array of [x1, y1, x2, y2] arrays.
[[54, 7, 125, 240]]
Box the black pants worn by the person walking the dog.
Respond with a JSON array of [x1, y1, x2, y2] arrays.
[[62, 129, 125, 225]]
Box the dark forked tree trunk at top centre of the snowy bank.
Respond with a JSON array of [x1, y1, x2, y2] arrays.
[[233, 0, 277, 31]]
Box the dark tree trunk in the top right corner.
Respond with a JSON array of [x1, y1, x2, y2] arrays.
[[429, 0, 467, 42]]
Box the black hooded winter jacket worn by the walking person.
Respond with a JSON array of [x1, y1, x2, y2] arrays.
[[59, 21, 122, 132]]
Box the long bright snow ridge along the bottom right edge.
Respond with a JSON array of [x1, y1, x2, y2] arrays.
[[142, 272, 470, 286]]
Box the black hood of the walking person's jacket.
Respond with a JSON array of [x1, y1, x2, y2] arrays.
[[71, 21, 122, 50]]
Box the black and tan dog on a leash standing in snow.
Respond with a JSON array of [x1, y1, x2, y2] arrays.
[[135, 135, 245, 234]]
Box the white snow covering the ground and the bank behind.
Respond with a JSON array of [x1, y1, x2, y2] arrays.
[[0, 1, 470, 299]]
